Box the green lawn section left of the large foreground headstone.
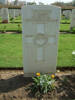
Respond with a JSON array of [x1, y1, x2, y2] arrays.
[[0, 34, 23, 68]]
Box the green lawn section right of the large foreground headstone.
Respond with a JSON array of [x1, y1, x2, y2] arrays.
[[58, 34, 75, 67]]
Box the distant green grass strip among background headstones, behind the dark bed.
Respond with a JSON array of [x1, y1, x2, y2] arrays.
[[0, 16, 75, 33]]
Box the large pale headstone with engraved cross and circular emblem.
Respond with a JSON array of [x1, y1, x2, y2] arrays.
[[22, 5, 60, 76]]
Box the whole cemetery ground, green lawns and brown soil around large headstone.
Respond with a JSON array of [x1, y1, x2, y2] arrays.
[[0, 17, 75, 100]]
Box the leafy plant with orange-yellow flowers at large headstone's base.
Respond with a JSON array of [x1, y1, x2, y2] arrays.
[[30, 73, 55, 96]]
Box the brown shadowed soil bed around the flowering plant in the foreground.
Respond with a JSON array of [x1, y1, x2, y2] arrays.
[[0, 70, 75, 100]]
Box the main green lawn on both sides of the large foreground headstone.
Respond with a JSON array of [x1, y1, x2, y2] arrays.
[[0, 34, 75, 68]]
